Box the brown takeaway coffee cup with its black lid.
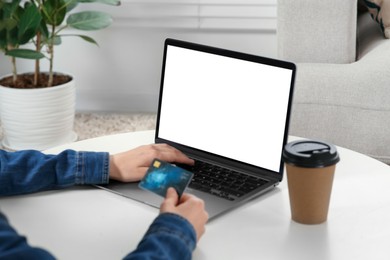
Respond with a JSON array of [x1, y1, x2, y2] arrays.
[[283, 140, 340, 224]]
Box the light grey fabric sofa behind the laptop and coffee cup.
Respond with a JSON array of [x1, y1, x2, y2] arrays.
[[277, 0, 390, 164]]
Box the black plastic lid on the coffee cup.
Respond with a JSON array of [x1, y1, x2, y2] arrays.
[[283, 140, 340, 168]]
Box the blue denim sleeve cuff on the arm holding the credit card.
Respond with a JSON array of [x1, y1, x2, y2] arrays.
[[124, 213, 196, 260]]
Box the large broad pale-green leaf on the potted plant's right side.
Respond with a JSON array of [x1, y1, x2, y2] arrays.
[[66, 11, 112, 31]]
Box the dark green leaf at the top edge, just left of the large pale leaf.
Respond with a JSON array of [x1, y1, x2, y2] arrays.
[[42, 0, 67, 26]]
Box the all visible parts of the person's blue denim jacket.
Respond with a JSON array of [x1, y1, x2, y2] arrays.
[[0, 150, 196, 260]]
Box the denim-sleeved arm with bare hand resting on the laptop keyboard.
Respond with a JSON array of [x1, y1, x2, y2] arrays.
[[0, 144, 194, 196]]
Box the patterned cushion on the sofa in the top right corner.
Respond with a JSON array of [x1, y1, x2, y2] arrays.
[[364, 0, 390, 38]]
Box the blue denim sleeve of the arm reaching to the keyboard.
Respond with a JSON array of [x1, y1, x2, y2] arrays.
[[0, 150, 109, 196]]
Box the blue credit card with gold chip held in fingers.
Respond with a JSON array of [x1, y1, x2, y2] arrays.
[[138, 159, 193, 197]]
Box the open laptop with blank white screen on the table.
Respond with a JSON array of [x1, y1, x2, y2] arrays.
[[98, 39, 296, 220]]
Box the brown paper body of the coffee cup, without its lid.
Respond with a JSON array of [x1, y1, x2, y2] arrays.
[[286, 164, 336, 224]]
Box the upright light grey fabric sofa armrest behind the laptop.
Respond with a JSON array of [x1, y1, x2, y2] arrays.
[[277, 0, 357, 63]]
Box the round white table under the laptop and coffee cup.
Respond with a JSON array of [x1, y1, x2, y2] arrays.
[[0, 131, 390, 260]]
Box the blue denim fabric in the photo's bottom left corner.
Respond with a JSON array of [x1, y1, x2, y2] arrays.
[[0, 213, 55, 260]]
